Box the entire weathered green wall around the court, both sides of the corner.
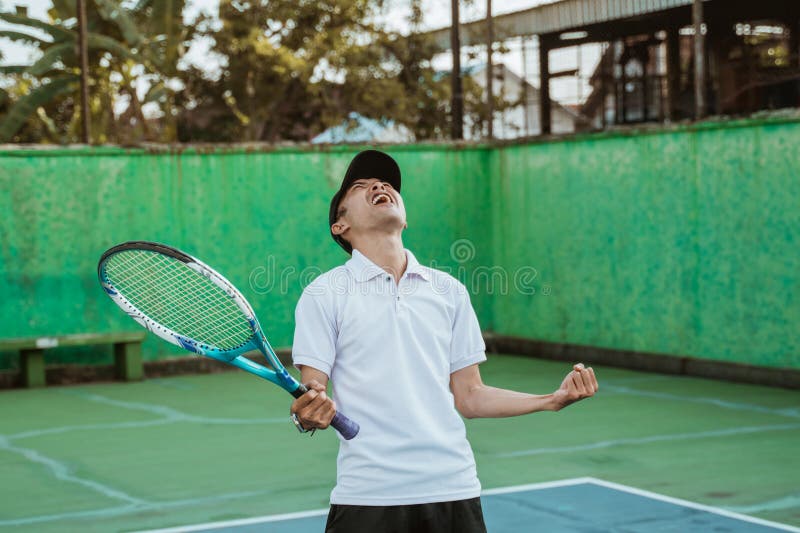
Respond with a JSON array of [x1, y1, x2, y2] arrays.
[[0, 117, 800, 368]]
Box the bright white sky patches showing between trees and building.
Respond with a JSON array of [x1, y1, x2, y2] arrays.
[[0, 0, 599, 103]]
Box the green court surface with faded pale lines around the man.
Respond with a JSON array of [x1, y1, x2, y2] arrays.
[[0, 355, 800, 532]]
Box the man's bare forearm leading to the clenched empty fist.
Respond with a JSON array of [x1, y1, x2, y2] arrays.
[[456, 384, 557, 418]]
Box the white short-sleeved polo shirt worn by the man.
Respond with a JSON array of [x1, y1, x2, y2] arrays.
[[292, 250, 486, 505]]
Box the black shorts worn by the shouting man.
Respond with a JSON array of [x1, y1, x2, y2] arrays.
[[325, 498, 486, 533]]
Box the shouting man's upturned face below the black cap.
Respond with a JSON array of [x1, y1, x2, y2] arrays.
[[337, 178, 406, 238]]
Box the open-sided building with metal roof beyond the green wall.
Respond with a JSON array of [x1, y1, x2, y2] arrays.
[[427, 0, 800, 133]]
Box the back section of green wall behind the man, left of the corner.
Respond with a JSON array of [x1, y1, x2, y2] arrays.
[[0, 146, 491, 368]]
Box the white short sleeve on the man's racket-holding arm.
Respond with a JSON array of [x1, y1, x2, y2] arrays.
[[292, 289, 337, 377]]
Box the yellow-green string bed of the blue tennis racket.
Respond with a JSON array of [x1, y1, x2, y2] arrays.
[[106, 250, 253, 350]]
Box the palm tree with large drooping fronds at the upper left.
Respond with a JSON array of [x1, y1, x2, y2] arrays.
[[0, 0, 186, 142]]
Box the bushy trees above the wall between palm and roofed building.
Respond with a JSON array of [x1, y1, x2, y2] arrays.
[[179, 0, 490, 142]]
